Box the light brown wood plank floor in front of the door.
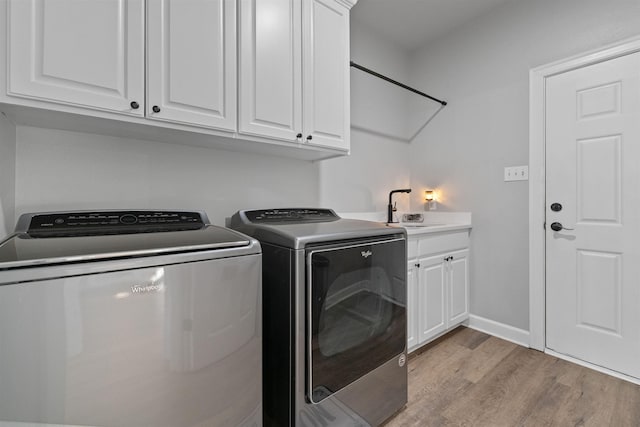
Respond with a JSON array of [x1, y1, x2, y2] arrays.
[[385, 327, 640, 427]]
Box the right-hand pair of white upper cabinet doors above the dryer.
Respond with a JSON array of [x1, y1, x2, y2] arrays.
[[238, 0, 353, 150]]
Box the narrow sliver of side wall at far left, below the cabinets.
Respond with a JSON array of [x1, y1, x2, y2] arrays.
[[0, 114, 16, 240]]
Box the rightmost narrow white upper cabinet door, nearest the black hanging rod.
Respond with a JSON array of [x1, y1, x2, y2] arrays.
[[302, 0, 350, 149]]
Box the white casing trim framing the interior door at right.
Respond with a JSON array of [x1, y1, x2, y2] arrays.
[[529, 37, 640, 351]]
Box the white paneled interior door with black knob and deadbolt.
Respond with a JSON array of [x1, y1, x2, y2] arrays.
[[545, 53, 640, 378]]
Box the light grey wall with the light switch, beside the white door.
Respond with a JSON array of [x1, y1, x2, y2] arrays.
[[408, 0, 640, 330]]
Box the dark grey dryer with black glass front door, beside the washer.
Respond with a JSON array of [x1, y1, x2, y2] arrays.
[[230, 208, 407, 426]]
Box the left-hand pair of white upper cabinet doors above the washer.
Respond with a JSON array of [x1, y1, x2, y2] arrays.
[[8, 0, 237, 132]]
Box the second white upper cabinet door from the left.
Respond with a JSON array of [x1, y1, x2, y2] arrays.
[[146, 0, 236, 131]]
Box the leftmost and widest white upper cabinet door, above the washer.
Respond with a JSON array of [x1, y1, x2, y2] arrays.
[[8, 0, 145, 115]]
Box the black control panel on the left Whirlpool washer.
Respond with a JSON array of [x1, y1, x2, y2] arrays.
[[26, 211, 206, 237]]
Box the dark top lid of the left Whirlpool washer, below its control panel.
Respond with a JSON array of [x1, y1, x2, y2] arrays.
[[0, 212, 259, 270]]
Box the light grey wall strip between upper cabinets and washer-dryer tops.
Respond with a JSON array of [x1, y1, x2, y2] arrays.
[[15, 126, 318, 225]]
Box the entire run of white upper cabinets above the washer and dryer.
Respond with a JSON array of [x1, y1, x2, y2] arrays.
[[0, 0, 356, 160]]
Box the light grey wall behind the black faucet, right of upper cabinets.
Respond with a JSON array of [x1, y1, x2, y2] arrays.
[[320, 20, 410, 212]]
